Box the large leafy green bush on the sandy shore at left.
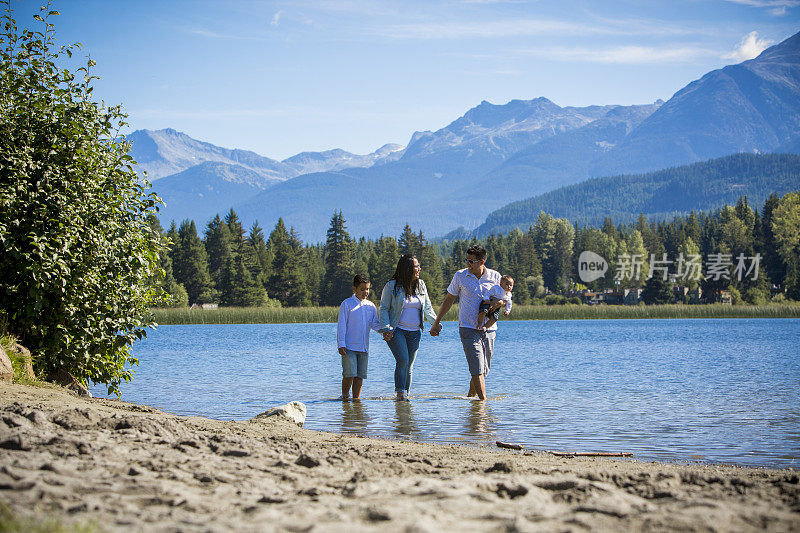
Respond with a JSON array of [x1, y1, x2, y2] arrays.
[[0, 4, 161, 392]]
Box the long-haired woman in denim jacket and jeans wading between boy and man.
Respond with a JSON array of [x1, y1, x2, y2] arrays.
[[378, 254, 436, 400]]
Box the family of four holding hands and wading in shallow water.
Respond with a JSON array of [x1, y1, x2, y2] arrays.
[[336, 245, 514, 400]]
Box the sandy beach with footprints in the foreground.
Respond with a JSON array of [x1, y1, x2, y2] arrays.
[[0, 384, 800, 532]]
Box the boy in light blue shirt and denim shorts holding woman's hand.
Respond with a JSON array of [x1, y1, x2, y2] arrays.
[[336, 274, 388, 400]]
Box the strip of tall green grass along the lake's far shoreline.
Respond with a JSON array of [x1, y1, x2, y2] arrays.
[[153, 304, 800, 325]]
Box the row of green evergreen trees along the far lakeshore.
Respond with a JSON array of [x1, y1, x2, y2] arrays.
[[150, 192, 800, 307]]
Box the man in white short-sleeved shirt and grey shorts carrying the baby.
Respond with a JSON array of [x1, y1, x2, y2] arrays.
[[431, 244, 500, 400]]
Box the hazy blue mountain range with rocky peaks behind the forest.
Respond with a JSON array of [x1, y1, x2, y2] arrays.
[[134, 33, 800, 242]]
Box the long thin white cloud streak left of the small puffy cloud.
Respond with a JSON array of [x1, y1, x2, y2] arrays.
[[520, 46, 719, 65]]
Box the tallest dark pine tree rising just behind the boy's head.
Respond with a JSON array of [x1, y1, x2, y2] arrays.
[[322, 211, 353, 305]]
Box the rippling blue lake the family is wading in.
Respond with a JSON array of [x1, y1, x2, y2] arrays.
[[92, 319, 800, 468]]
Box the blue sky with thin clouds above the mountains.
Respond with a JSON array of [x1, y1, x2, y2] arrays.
[[13, 0, 800, 159]]
